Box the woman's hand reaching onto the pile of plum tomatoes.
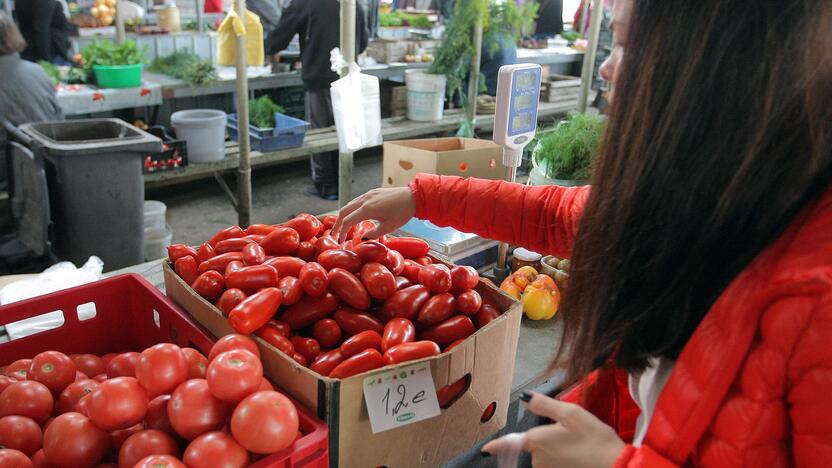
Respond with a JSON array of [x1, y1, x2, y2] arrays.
[[332, 187, 416, 242]]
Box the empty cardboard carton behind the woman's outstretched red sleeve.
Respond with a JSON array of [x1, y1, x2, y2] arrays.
[[382, 137, 505, 187]]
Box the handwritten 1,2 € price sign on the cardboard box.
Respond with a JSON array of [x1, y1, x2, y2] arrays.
[[364, 363, 439, 434]]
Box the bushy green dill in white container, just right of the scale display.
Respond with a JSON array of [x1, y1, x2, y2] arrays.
[[529, 113, 604, 186]]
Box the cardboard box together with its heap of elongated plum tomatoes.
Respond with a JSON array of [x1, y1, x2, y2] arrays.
[[164, 215, 522, 467]]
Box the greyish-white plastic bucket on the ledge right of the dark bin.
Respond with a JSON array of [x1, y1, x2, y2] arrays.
[[170, 109, 228, 163]]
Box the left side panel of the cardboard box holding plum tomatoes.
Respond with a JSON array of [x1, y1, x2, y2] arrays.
[[163, 263, 326, 419]]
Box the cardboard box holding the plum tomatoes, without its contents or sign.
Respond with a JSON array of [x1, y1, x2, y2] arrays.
[[164, 263, 522, 468]]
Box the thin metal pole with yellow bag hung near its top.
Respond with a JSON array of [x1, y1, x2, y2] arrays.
[[234, 0, 251, 228]]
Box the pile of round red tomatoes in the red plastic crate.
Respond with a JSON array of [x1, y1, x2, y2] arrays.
[[0, 335, 300, 468]]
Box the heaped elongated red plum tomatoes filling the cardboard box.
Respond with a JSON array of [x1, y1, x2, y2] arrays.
[[168, 214, 500, 379]]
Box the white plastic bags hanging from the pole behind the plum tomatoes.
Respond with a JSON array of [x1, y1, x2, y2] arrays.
[[330, 48, 384, 153]]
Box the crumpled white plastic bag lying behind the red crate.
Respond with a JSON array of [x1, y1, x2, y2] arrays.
[[0, 256, 104, 340]]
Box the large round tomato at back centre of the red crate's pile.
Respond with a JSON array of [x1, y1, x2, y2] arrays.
[[136, 343, 188, 395]]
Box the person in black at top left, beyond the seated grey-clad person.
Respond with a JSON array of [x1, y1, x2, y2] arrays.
[[15, 0, 71, 65]]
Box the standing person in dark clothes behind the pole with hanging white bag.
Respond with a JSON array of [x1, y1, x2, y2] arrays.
[[266, 0, 367, 200]]
